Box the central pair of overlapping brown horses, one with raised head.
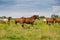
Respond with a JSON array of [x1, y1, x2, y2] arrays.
[[15, 15, 39, 27]]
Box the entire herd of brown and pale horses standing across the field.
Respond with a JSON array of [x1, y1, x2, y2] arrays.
[[0, 15, 60, 27]]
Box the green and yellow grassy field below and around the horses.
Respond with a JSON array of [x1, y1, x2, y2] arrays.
[[0, 19, 60, 40]]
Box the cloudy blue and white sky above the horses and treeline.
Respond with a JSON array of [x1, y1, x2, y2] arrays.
[[0, 0, 60, 17]]
